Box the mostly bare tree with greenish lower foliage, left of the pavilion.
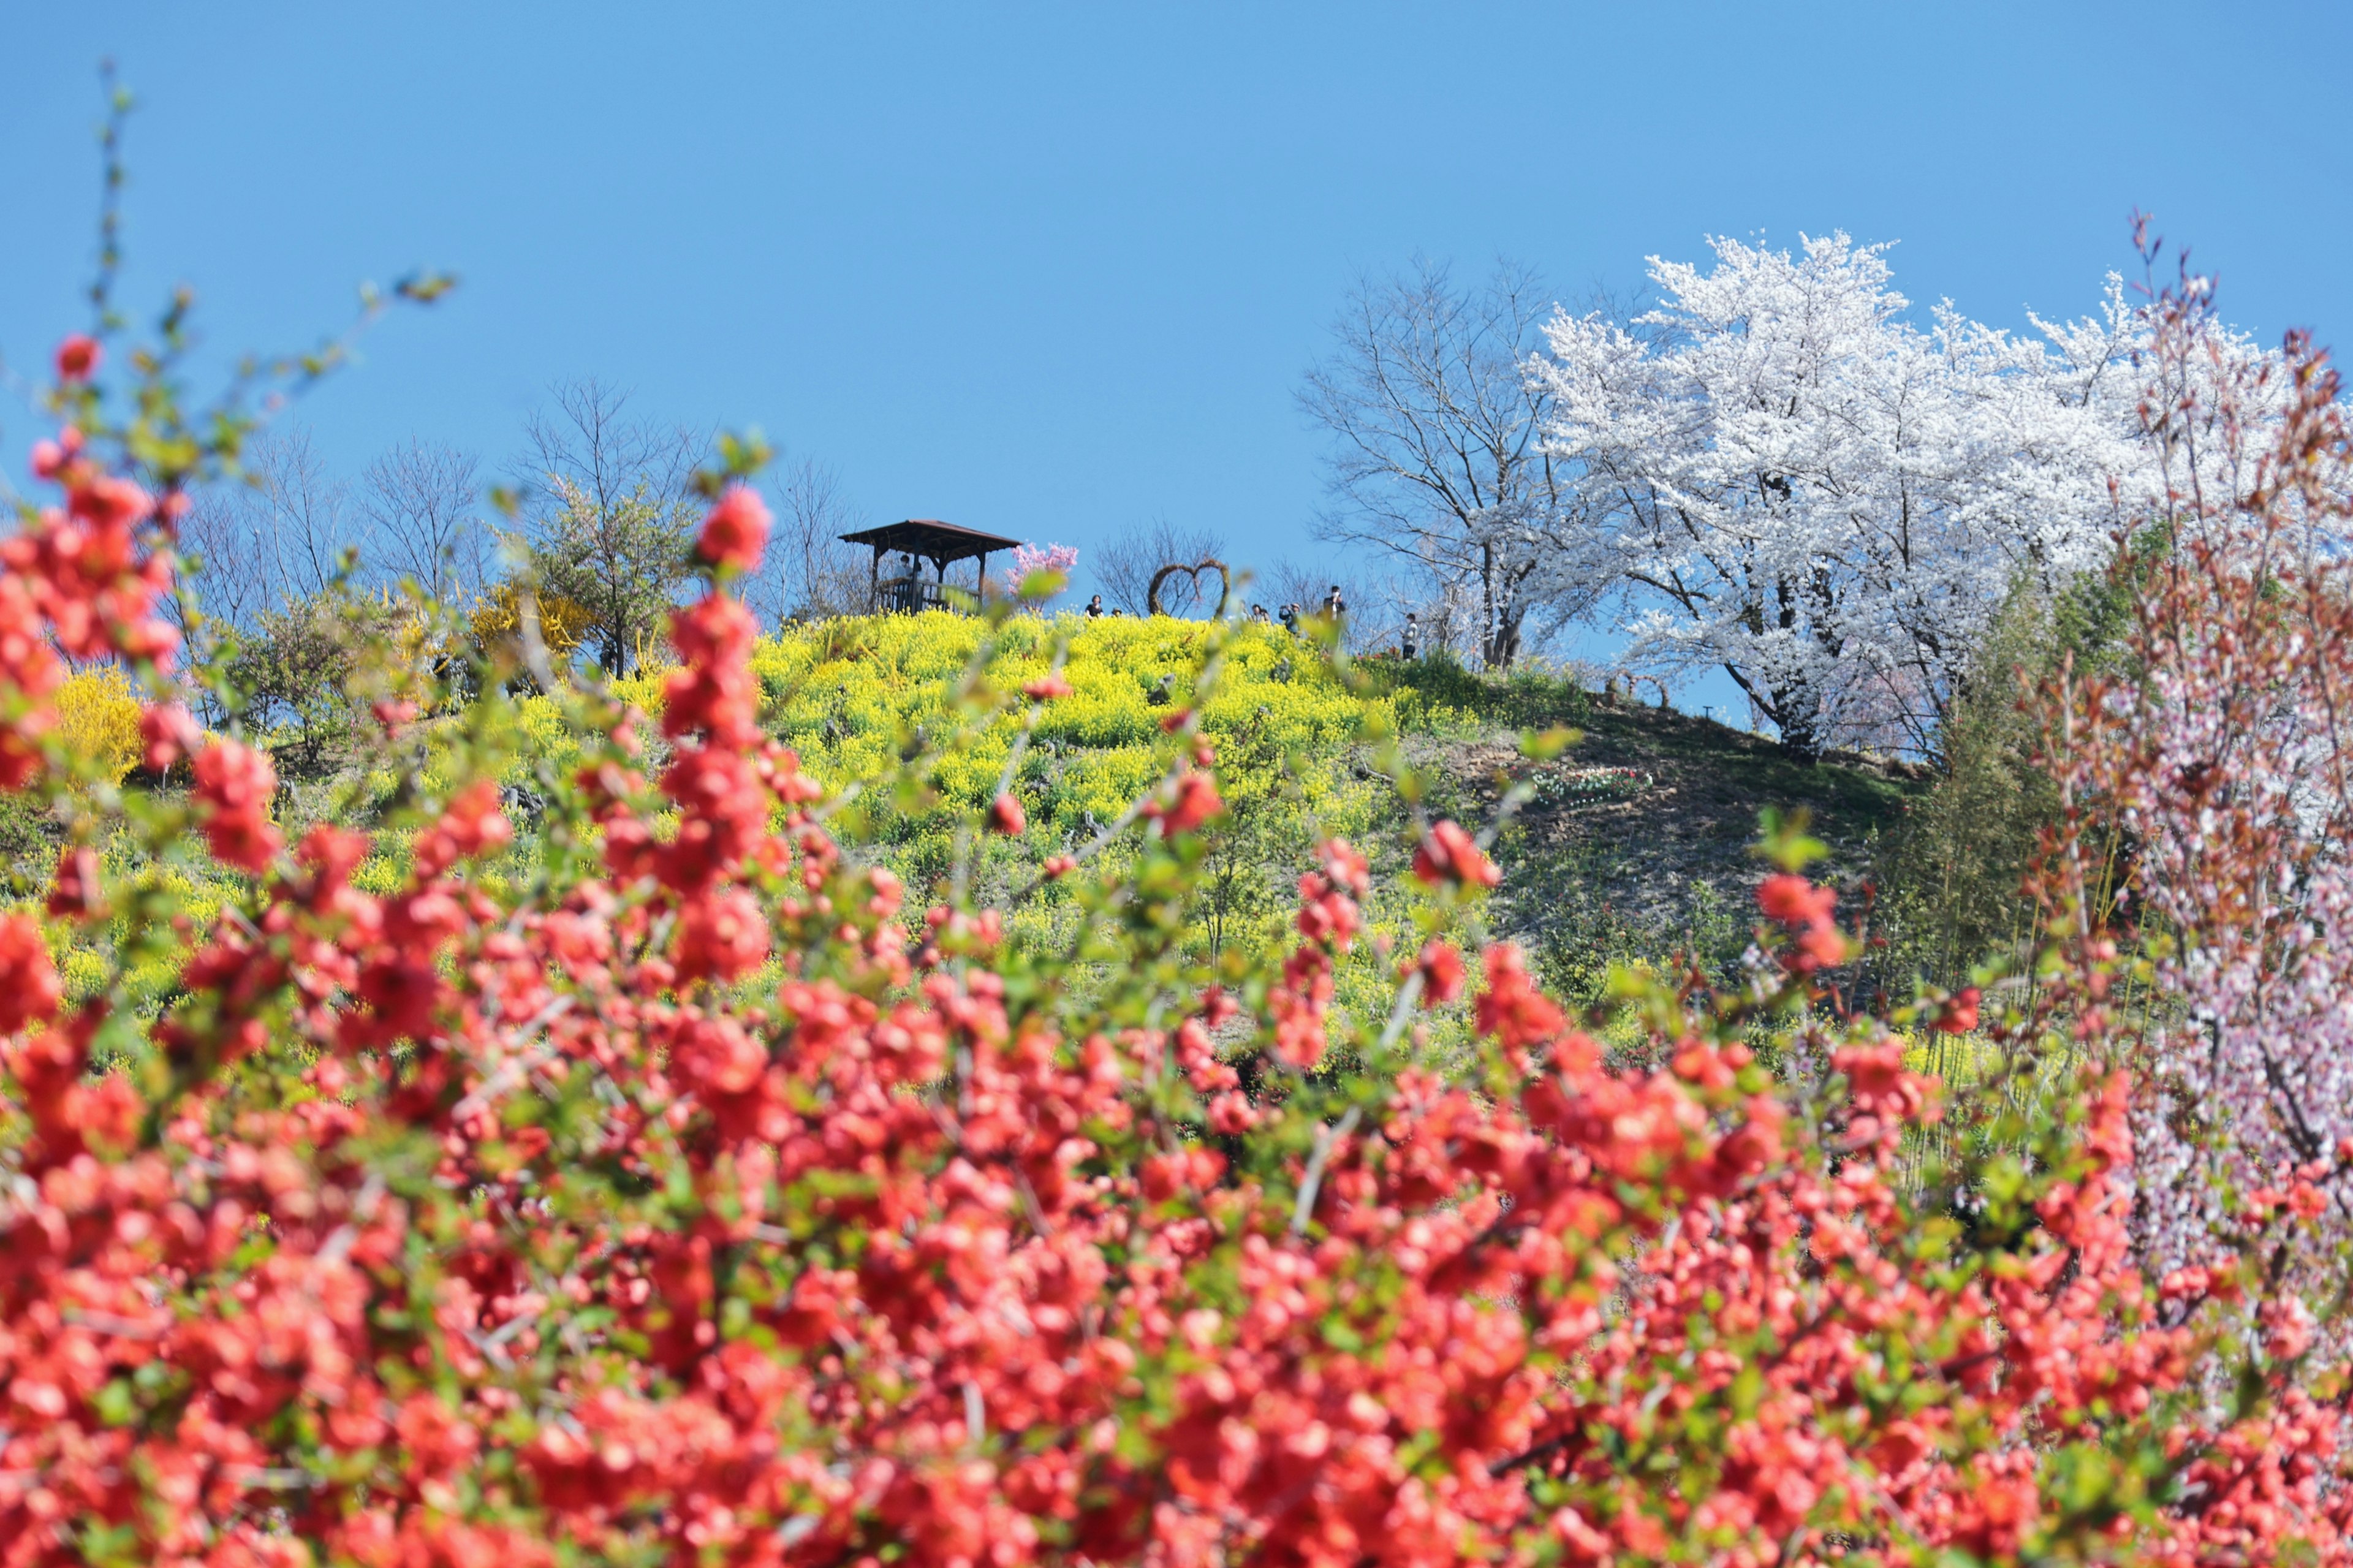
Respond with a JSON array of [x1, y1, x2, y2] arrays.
[[518, 377, 708, 673]]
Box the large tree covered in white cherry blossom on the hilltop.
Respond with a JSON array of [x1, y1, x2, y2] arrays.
[[1527, 233, 2146, 756]]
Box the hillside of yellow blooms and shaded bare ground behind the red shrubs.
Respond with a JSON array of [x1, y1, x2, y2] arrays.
[[18, 615, 1915, 1021]]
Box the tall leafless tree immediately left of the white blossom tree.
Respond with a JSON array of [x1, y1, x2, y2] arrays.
[[1299, 262, 1588, 668]]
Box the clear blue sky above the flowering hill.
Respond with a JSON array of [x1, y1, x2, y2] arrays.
[[0, 0, 2353, 692]]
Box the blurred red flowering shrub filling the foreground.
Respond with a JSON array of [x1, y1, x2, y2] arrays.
[[0, 259, 2348, 1568]]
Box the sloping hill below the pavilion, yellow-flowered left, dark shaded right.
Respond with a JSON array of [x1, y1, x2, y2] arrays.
[[23, 615, 1913, 1021]]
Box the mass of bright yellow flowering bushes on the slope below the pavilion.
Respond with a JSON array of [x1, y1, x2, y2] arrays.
[[506, 612, 1463, 947]]
